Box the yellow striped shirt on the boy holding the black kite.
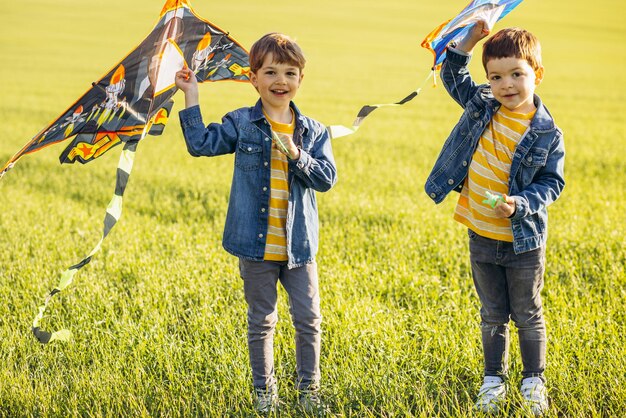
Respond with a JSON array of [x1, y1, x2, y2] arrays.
[[263, 112, 295, 261]]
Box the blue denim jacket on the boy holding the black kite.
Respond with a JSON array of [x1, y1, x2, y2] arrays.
[[179, 100, 337, 268]]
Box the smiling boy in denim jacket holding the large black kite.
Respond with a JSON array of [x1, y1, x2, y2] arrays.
[[176, 33, 337, 413]]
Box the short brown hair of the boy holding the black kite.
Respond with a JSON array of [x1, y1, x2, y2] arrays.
[[250, 32, 306, 73]]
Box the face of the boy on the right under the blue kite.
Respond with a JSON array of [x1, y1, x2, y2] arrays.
[[486, 57, 543, 113]]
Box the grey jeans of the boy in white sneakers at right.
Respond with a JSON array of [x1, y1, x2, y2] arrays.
[[468, 230, 546, 380]]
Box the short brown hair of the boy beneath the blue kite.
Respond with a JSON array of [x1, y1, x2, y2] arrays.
[[483, 28, 541, 71]]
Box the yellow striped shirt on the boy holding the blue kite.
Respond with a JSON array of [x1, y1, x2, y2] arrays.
[[454, 106, 535, 242]]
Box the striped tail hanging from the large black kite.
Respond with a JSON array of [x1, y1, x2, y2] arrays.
[[32, 140, 139, 344]]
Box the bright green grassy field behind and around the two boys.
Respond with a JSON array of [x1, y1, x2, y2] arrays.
[[0, 0, 626, 417]]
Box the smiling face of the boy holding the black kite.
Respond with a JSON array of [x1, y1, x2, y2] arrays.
[[250, 54, 304, 116]]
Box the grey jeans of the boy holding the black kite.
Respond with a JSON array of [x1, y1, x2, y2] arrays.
[[239, 259, 322, 390]]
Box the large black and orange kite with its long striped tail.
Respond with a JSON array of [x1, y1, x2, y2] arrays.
[[0, 0, 250, 343]]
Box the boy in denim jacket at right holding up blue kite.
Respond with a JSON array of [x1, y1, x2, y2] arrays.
[[425, 22, 565, 415]]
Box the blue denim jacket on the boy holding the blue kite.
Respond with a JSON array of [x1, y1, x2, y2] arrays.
[[425, 49, 565, 254]]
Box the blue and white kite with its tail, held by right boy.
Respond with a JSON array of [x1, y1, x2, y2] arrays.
[[328, 0, 523, 138]]
